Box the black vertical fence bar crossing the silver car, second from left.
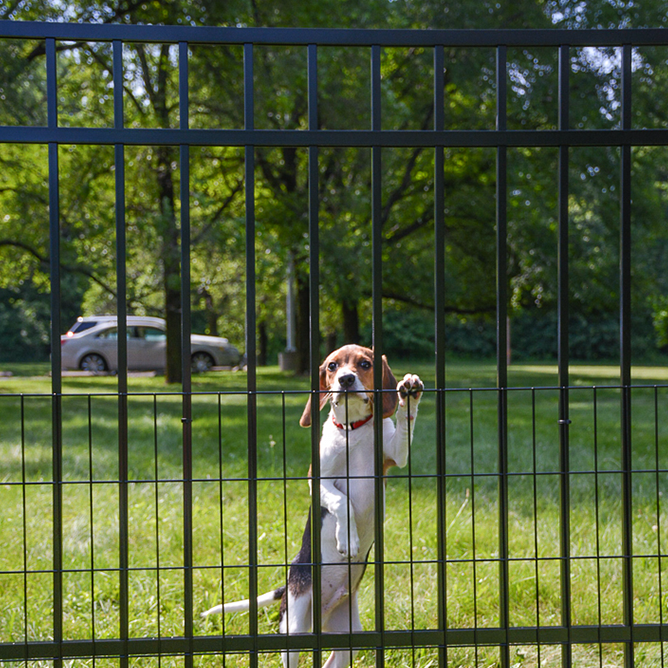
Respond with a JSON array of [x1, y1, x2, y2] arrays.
[[113, 40, 130, 668]]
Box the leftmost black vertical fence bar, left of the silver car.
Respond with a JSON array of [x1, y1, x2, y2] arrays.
[[46, 38, 63, 668]]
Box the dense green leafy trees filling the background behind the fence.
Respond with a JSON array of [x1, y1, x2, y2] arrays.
[[0, 0, 668, 368]]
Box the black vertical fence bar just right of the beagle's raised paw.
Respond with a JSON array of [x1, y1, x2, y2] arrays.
[[434, 45, 447, 666]]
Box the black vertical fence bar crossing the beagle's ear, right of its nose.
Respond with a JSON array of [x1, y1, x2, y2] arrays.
[[371, 45, 385, 668]]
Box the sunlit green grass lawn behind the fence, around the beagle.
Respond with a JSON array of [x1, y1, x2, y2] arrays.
[[0, 363, 668, 668]]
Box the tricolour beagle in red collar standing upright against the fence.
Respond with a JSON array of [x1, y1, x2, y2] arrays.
[[203, 345, 424, 668]]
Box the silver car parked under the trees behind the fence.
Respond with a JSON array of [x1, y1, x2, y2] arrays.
[[60, 315, 241, 373]]
